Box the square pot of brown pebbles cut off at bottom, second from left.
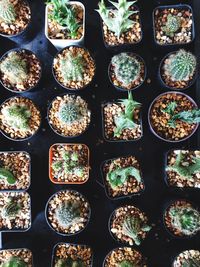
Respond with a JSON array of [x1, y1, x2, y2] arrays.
[[51, 243, 93, 267]]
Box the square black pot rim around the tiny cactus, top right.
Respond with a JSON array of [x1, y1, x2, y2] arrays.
[[152, 4, 195, 47]]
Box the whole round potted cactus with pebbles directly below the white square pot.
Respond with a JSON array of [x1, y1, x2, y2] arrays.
[[52, 46, 96, 91]]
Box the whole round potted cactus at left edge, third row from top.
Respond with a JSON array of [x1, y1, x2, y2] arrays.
[[0, 97, 41, 141]]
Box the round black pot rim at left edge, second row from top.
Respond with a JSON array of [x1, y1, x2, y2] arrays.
[[0, 48, 42, 94]]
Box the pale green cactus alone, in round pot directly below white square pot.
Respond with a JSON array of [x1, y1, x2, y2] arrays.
[[60, 51, 85, 83]]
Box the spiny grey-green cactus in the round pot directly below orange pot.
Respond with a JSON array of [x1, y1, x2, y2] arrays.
[[56, 201, 81, 228]]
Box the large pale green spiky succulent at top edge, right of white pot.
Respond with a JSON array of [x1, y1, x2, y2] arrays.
[[97, 0, 138, 38]]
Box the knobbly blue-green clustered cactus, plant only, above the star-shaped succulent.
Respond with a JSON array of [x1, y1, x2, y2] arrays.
[[111, 53, 141, 87]]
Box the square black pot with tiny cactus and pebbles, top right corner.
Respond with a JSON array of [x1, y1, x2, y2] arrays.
[[153, 5, 195, 45]]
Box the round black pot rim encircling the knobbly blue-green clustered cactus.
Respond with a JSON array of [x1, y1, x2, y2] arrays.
[[108, 52, 147, 92]]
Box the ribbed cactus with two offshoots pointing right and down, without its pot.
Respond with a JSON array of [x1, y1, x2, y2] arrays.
[[122, 216, 151, 246]]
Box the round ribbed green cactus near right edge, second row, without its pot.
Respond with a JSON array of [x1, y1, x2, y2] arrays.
[[164, 49, 197, 82]]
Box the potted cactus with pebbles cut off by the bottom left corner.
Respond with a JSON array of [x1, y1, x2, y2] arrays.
[[0, 248, 33, 267]]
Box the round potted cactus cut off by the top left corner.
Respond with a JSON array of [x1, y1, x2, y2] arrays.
[[0, 0, 31, 37]]
